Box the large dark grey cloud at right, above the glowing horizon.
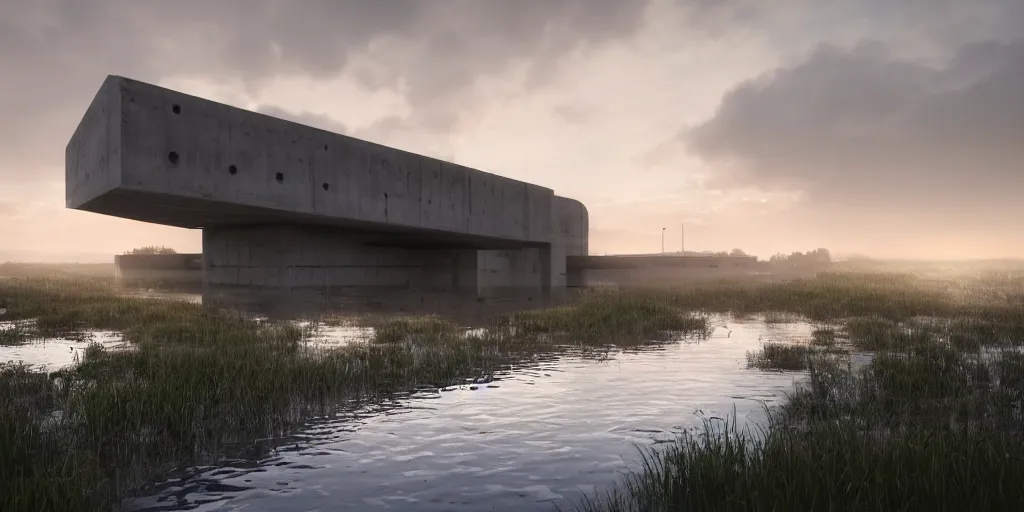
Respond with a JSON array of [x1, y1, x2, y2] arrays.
[[684, 40, 1024, 230]]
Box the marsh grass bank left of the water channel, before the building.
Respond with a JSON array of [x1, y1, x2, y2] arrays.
[[0, 276, 707, 511]]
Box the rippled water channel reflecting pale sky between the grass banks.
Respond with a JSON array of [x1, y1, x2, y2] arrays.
[[121, 318, 811, 512]]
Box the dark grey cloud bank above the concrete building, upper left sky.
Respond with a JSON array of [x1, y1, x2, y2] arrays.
[[0, 0, 646, 178]]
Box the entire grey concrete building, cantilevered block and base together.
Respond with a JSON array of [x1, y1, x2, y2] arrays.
[[66, 76, 589, 311]]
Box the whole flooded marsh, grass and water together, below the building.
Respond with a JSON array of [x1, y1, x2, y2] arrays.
[[0, 274, 1024, 510]]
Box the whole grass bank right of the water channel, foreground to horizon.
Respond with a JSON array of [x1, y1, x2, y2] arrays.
[[578, 278, 1024, 512]]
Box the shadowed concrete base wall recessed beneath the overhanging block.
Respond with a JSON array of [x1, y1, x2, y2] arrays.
[[203, 226, 550, 301]]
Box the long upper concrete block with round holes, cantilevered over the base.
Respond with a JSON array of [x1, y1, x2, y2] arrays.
[[66, 77, 586, 248]]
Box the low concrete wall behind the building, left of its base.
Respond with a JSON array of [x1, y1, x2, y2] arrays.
[[114, 254, 203, 291]]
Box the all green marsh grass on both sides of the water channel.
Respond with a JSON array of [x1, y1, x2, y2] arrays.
[[0, 266, 1024, 510]]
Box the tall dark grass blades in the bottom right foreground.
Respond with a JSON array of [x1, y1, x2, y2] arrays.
[[581, 413, 1024, 511]]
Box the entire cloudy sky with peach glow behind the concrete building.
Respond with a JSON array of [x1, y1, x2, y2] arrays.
[[0, 0, 1024, 258]]
